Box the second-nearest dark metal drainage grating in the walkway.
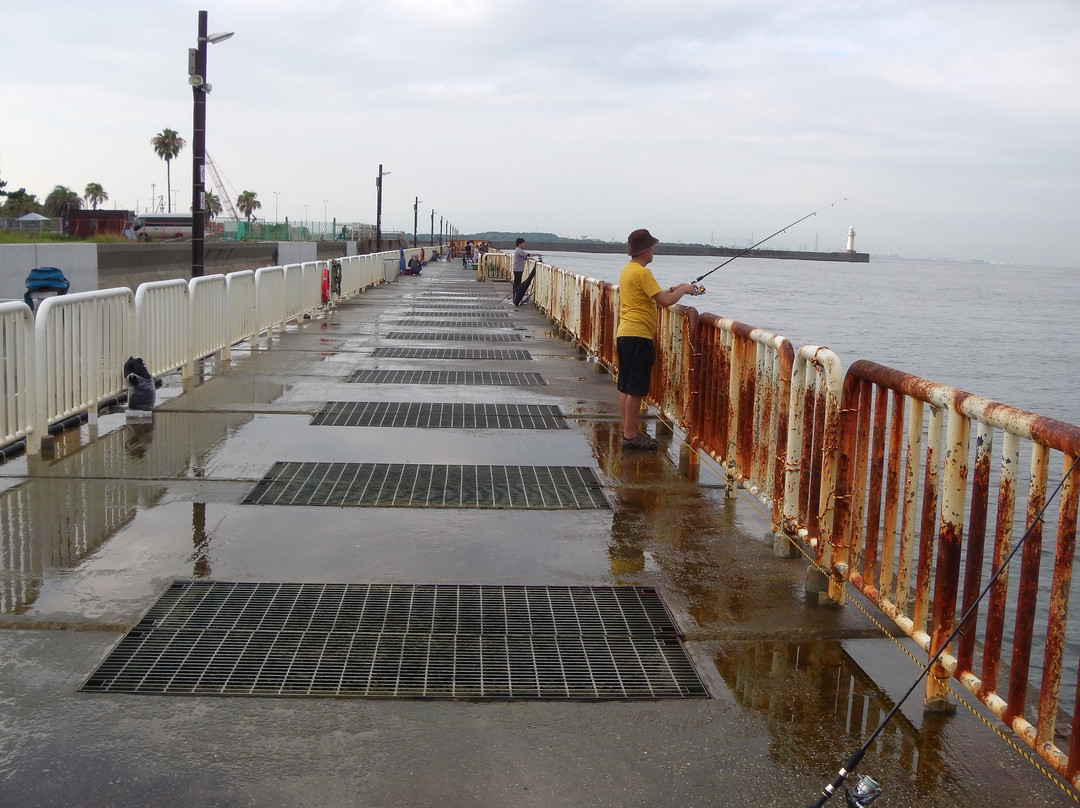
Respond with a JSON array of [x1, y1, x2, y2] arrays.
[[242, 461, 610, 511]]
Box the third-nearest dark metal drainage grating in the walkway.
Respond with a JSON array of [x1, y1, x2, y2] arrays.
[[311, 401, 570, 429]]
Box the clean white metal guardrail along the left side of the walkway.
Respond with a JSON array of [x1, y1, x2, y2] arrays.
[[0, 248, 422, 455]]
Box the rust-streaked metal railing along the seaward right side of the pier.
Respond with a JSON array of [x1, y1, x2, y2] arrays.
[[520, 253, 1080, 787]]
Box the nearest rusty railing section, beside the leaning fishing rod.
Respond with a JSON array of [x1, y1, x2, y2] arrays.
[[831, 361, 1080, 785]]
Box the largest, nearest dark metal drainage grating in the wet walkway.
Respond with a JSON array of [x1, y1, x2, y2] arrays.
[[81, 580, 708, 700]]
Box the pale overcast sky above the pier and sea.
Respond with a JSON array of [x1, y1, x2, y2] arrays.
[[0, 0, 1080, 267]]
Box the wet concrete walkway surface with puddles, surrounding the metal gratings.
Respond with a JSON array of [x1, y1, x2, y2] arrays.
[[0, 265, 1068, 806]]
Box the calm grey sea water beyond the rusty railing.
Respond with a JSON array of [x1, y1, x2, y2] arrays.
[[544, 253, 1080, 425]]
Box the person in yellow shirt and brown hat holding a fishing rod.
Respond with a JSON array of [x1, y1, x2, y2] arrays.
[[616, 230, 699, 452]]
